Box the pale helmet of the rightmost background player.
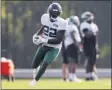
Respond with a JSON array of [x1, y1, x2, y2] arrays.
[[81, 11, 94, 21]]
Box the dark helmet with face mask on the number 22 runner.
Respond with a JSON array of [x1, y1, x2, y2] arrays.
[[48, 3, 62, 20]]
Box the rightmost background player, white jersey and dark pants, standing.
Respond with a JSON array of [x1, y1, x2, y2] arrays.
[[80, 11, 99, 80]]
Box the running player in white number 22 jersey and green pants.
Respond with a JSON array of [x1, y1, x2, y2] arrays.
[[30, 3, 67, 86]]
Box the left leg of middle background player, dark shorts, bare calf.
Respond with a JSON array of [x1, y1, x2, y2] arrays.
[[62, 41, 69, 81]]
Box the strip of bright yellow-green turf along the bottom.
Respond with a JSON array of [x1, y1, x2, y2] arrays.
[[2, 79, 111, 89]]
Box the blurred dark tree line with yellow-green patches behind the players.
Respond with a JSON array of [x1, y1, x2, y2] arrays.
[[1, 1, 111, 68]]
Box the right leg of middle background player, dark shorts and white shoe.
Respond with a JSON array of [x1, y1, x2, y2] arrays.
[[67, 44, 81, 82]]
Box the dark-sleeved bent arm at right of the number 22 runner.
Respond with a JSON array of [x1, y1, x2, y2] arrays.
[[48, 30, 65, 44]]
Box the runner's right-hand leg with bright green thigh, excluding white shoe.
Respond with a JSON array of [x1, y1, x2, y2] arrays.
[[35, 47, 59, 81]]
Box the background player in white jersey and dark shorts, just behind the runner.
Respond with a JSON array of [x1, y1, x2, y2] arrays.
[[62, 16, 81, 82]]
